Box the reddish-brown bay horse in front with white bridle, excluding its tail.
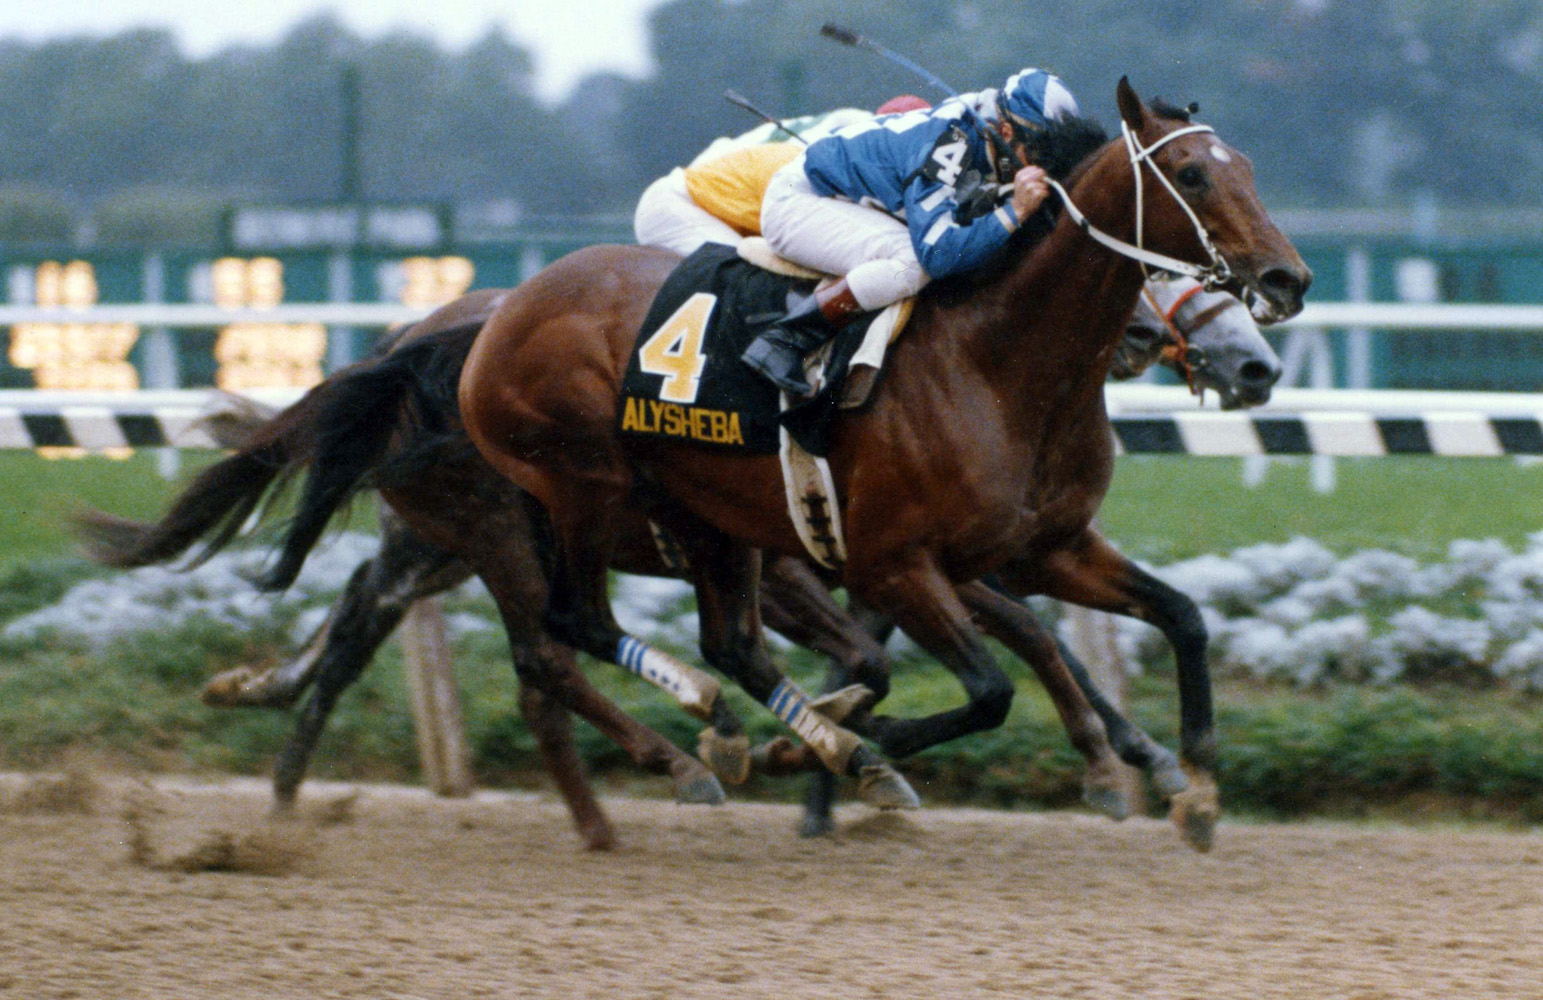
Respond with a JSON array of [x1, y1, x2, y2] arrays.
[[460, 79, 1312, 849]]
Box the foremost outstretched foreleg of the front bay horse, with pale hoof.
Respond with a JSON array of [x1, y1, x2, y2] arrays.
[[1043, 529, 1219, 850]]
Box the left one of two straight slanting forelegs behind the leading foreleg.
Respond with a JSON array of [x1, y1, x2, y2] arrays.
[[958, 582, 1131, 819]]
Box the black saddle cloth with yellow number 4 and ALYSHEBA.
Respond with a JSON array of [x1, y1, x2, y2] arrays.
[[620, 244, 900, 455]]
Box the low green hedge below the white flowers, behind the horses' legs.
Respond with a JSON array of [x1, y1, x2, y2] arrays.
[[0, 614, 1543, 823]]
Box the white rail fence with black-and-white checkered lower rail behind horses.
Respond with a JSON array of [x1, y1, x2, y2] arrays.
[[0, 302, 1543, 453]]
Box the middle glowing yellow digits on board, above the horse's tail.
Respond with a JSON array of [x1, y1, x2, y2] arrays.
[[211, 258, 327, 392]]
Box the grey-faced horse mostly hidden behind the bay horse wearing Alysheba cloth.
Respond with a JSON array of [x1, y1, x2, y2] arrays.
[[183, 271, 1281, 849]]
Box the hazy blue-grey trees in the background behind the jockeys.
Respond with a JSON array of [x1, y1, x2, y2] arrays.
[[0, 0, 1543, 239]]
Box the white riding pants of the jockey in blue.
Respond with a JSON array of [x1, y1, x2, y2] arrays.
[[761, 156, 929, 312]]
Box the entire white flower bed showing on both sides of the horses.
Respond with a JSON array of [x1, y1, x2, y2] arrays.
[[3, 532, 1543, 691]]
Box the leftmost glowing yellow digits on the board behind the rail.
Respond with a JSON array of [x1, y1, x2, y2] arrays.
[[9, 261, 139, 389]]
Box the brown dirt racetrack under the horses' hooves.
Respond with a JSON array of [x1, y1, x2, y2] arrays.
[[0, 778, 1543, 1000]]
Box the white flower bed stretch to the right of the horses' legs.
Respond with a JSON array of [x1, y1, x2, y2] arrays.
[[1119, 532, 1543, 691]]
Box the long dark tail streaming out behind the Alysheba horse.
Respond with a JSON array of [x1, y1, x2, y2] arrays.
[[74, 324, 480, 590]]
